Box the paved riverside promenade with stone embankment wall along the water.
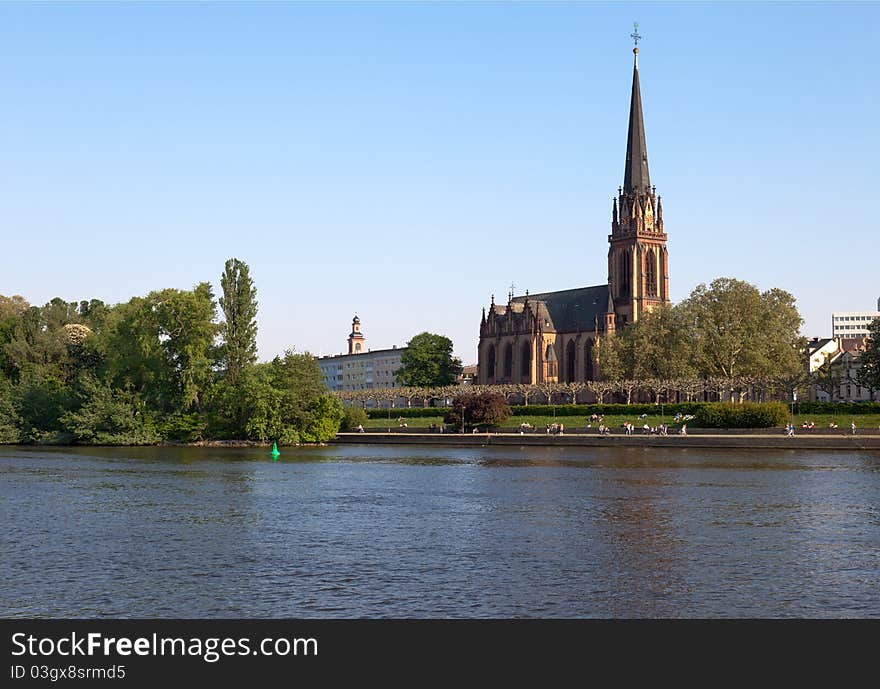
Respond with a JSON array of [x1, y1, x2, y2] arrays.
[[333, 429, 880, 452]]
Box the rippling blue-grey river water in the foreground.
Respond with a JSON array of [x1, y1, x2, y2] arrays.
[[0, 445, 880, 618]]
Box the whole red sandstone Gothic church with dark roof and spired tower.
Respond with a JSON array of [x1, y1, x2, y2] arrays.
[[477, 39, 669, 385]]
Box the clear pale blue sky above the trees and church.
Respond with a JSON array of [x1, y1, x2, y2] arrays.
[[0, 2, 880, 363]]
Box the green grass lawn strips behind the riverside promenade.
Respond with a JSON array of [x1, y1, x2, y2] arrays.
[[364, 414, 880, 433]]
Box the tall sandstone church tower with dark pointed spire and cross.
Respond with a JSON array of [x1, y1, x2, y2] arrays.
[[608, 31, 669, 326]]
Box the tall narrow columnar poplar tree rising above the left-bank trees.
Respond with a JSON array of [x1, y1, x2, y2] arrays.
[[220, 258, 257, 386]]
